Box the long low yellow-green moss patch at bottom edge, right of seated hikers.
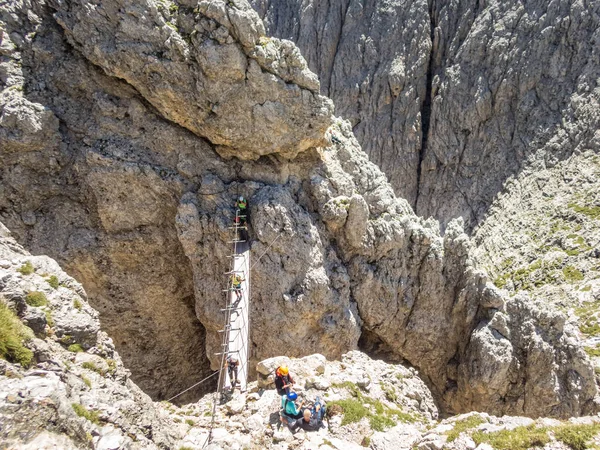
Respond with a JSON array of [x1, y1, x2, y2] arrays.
[[471, 425, 550, 450]]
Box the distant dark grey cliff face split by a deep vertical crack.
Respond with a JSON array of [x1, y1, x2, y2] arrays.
[[252, 0, 600, 229]]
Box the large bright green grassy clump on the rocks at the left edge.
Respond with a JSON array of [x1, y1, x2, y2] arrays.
[[0, 301, 33, 368]]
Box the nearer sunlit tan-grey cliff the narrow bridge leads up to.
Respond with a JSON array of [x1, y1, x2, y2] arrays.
[[0, 0, 597, 416]]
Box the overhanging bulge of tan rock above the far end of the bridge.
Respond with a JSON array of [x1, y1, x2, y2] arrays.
[[55, 0, 333, 159]]
